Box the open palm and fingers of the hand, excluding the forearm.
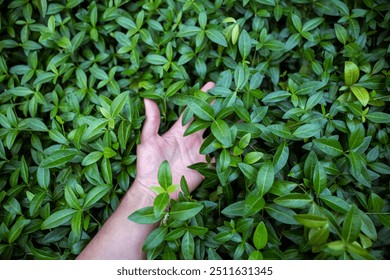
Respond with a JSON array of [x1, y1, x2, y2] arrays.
[[135, 82, 215, 199]]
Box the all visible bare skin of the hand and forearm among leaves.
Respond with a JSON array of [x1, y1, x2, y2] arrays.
[[77, 82, 214, 260]]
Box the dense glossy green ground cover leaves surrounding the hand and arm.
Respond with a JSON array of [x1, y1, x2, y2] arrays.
[[0, 0, 390, 259]]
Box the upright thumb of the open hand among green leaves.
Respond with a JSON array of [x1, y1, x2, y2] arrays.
[[141, 98, 160, 141]]
